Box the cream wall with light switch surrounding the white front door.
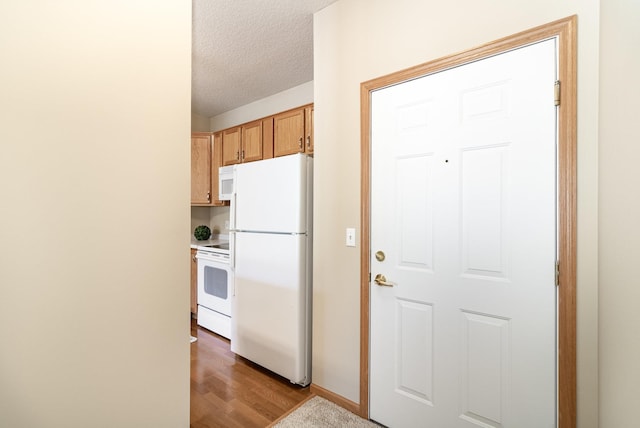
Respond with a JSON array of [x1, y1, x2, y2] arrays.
[[313, 0, 599, 427]]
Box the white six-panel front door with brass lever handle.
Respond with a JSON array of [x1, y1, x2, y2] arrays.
[[369, 39, 557, 428]]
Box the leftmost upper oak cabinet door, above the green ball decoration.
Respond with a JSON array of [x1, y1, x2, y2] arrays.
[[191, 133, 211, 205]]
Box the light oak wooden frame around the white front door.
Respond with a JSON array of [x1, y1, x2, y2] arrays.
[[356, 15, 577, 428]]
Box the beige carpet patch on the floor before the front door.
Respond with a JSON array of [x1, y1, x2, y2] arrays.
[[269, 396, 380, 428]]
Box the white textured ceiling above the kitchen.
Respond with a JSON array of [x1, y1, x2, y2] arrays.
[[191, 0, 336, 117]]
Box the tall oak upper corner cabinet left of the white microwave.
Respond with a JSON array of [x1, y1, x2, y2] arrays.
[[191, 132, 225, 206]]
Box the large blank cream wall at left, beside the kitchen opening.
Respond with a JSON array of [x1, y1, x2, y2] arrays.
[[0, 0, 191, 428]]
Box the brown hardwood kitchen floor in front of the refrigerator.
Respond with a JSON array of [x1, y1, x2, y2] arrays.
[[191, 320, 311, 428]]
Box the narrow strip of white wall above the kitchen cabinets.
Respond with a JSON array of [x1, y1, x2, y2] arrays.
[[210, 81, 313, 131]]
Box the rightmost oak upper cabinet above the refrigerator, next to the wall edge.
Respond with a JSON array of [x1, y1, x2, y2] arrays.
[[273, 105, 313, 157]]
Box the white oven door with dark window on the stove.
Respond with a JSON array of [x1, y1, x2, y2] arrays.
[[196, 251, 233, 317]]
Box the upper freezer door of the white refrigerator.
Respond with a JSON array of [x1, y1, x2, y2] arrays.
[[233, 154, 311, 233]]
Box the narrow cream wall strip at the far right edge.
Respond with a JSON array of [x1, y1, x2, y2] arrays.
[[599, 0, 640, 428]]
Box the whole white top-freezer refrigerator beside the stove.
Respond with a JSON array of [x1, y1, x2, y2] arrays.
[[230, 154, 313, 386]]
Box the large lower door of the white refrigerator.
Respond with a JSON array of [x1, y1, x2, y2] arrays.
[[231, 233, 311, 385]]
